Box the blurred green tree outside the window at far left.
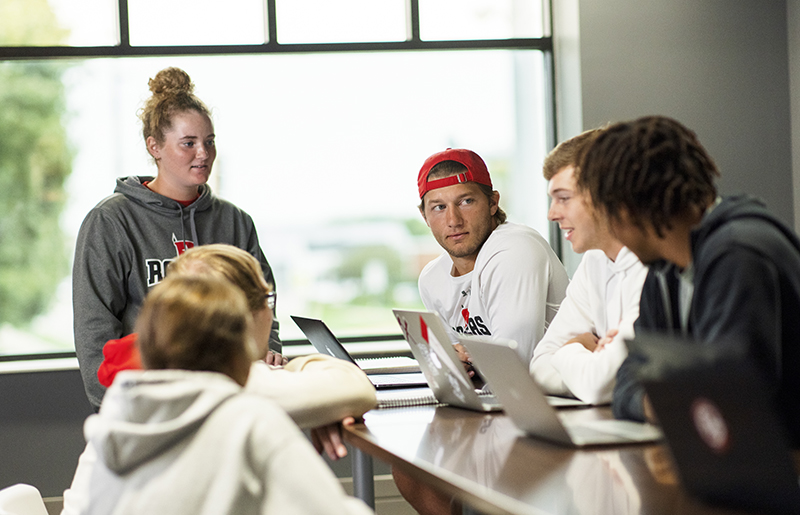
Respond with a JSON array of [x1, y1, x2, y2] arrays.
[[0, 0, 72, 325]]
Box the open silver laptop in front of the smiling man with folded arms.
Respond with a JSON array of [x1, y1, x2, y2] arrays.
[[458, 335, 661, 447]]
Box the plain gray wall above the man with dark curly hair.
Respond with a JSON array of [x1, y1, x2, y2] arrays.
[[576, 0, 797, 225]]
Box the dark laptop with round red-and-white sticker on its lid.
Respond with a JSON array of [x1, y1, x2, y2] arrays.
[[626, 333, 800, 513]]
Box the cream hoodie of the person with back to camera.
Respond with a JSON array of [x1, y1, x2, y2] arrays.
[[64, 370, 370, 515]]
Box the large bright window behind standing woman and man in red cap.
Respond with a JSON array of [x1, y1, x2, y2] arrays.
[[0, 0, 552, 354]]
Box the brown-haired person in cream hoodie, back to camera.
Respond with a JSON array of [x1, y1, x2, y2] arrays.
[[63, 275, 370, 515]]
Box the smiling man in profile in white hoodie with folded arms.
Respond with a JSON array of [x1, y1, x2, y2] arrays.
[[530, 129, 647, 404]]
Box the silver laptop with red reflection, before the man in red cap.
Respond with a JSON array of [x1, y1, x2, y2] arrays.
[[392, 309, 502, 411]]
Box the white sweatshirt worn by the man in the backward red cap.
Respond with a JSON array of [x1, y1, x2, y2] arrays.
[[419, 223, 569, 363]]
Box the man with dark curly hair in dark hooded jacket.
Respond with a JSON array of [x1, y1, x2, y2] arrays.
[[578, 116, 800, 445]]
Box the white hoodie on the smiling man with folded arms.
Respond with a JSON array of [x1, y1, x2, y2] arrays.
[[530, 247, 647, 404]]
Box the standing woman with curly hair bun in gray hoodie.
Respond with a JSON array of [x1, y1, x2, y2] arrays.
[[72, 68, 281, 410]]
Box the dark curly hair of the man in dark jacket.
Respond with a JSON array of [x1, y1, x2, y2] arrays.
[[578, 116, 719, 237]]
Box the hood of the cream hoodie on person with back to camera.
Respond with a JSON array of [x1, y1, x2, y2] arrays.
[[84, 370, 241, 474]]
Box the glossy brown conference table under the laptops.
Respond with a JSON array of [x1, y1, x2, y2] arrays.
[[345, 406, 756, 515]]
